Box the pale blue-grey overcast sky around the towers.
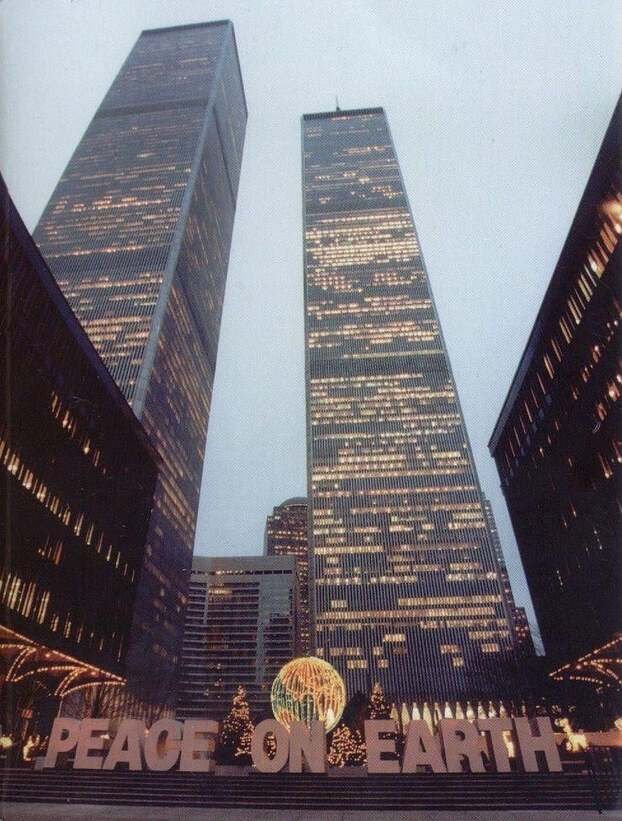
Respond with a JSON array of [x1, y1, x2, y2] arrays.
[[0, 0, 622, 636]]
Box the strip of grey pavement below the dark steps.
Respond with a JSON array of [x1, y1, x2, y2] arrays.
[[0, 803, 622, 821]]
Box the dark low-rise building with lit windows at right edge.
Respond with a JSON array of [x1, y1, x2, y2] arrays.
[[489, 96, 622, 686]]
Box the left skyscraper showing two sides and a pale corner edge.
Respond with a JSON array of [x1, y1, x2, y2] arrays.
[[35, 21, 247, 706]]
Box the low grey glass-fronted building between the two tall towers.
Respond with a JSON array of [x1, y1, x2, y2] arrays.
[[177, 556, 298, 721]]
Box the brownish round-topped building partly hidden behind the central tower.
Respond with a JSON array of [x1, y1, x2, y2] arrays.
[[264, 498, 313, 655]]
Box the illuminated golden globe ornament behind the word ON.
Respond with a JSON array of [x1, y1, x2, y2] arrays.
[[271, 656, 346, 732]]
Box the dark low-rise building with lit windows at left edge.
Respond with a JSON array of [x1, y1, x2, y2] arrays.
[[0, 178, 158, 734]]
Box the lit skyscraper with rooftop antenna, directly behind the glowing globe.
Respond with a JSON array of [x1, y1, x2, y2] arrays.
[[302, 108, 512, 701]]
